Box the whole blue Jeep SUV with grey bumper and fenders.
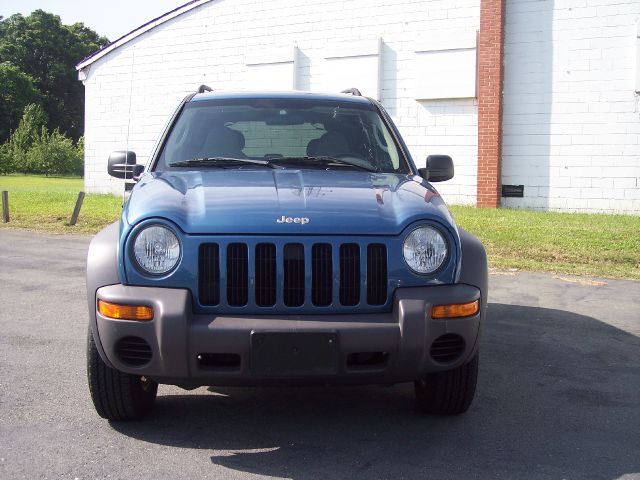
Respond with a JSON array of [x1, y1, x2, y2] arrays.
[[87, 86, 487, 420]]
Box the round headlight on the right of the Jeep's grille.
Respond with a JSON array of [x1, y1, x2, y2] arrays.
[[402, 227, 447, 274]]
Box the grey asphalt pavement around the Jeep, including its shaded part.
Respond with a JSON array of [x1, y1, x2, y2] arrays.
[[0, 229, 640, 480]]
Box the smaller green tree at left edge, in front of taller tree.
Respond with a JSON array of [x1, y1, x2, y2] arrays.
[[0, 62, 42, 143]]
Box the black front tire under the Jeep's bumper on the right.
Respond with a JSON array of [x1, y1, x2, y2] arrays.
[[415, 353, 478, 415]]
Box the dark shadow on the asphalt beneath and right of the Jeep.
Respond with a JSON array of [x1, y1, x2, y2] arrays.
[[112, 304, 640, 479]]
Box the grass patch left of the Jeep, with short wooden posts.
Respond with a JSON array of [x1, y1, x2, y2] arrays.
[[0, 175, 122, 233]]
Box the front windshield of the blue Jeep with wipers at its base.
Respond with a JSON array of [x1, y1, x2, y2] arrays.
[[156, 99, 408, 173]]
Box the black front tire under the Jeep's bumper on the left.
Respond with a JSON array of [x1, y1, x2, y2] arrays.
[[87, 331, 158, 420]]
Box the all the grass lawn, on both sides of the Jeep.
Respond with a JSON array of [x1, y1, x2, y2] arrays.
[[0, 175, 640, 279]]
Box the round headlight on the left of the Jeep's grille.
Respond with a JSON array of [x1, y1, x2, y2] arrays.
[[133, 225, 180, 275]]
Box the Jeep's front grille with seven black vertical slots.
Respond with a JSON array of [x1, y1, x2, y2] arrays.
[[198, 242, 389, 312]]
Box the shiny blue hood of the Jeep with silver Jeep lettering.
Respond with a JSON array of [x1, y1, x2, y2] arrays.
[[124, 169, 453, 235]]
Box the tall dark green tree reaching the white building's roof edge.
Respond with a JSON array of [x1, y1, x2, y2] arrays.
[[0, 10, 108, 140]]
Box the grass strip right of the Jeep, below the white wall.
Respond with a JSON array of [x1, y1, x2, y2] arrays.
[[451, 206, 640, 279]]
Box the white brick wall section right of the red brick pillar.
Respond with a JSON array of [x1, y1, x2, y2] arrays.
[[502, 0, 640, 213]]
